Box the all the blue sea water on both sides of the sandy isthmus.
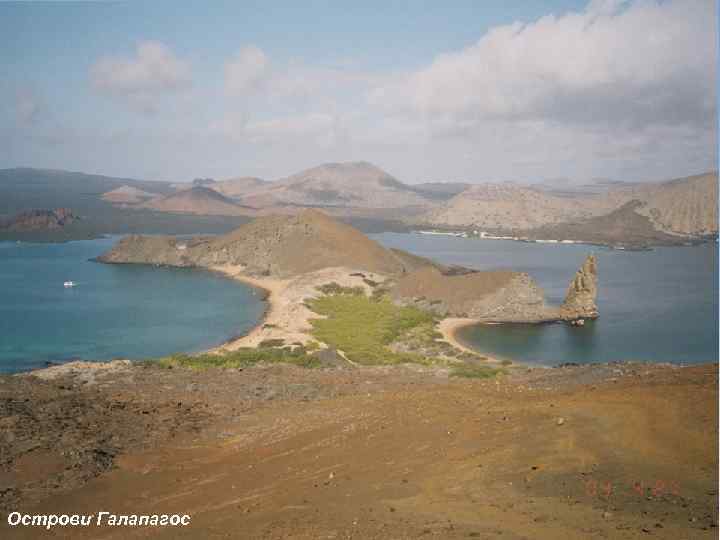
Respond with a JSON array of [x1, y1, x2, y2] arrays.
[[0, 233, 718, 373]]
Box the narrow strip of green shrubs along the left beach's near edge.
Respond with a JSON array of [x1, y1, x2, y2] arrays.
[[159, 347, 320, 369]]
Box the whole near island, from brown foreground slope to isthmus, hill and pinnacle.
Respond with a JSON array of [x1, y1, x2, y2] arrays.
[[0, 211, 718, 539]]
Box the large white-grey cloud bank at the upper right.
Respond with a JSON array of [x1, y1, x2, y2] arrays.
[[370, 0, 717, 134]]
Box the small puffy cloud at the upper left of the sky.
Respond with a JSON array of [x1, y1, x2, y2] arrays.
[[90, 41, 191, 112]]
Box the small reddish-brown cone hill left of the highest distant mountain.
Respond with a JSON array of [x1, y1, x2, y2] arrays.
[[143, 186, 253, 216]]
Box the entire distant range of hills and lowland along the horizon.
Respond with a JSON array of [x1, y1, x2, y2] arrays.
[[0, 161, 718, 240]]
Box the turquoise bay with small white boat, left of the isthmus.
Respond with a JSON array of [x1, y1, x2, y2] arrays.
[[0, 238, 265, 373]]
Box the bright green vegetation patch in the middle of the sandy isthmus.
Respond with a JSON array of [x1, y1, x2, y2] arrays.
[[307, 294, 434, 365]]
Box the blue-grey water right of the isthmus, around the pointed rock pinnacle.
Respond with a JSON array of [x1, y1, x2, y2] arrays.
[[375, 233, 718, 365]]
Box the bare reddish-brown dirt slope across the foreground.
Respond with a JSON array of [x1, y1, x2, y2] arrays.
[[0, 364, 718, 540]]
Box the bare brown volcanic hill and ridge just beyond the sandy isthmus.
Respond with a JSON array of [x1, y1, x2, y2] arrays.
[[98, 210, 597, 322]]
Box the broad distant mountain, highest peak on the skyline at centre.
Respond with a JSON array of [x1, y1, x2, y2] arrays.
[[243, 161, 430, 208]]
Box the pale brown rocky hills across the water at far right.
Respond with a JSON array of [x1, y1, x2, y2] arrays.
[[413, 171, 718, 245]]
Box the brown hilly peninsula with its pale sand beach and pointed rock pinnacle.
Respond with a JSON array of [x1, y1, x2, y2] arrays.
[[98, 210, 598, 359]]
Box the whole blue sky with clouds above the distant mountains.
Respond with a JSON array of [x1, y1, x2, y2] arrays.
[[0, 0, 718, 183]]
